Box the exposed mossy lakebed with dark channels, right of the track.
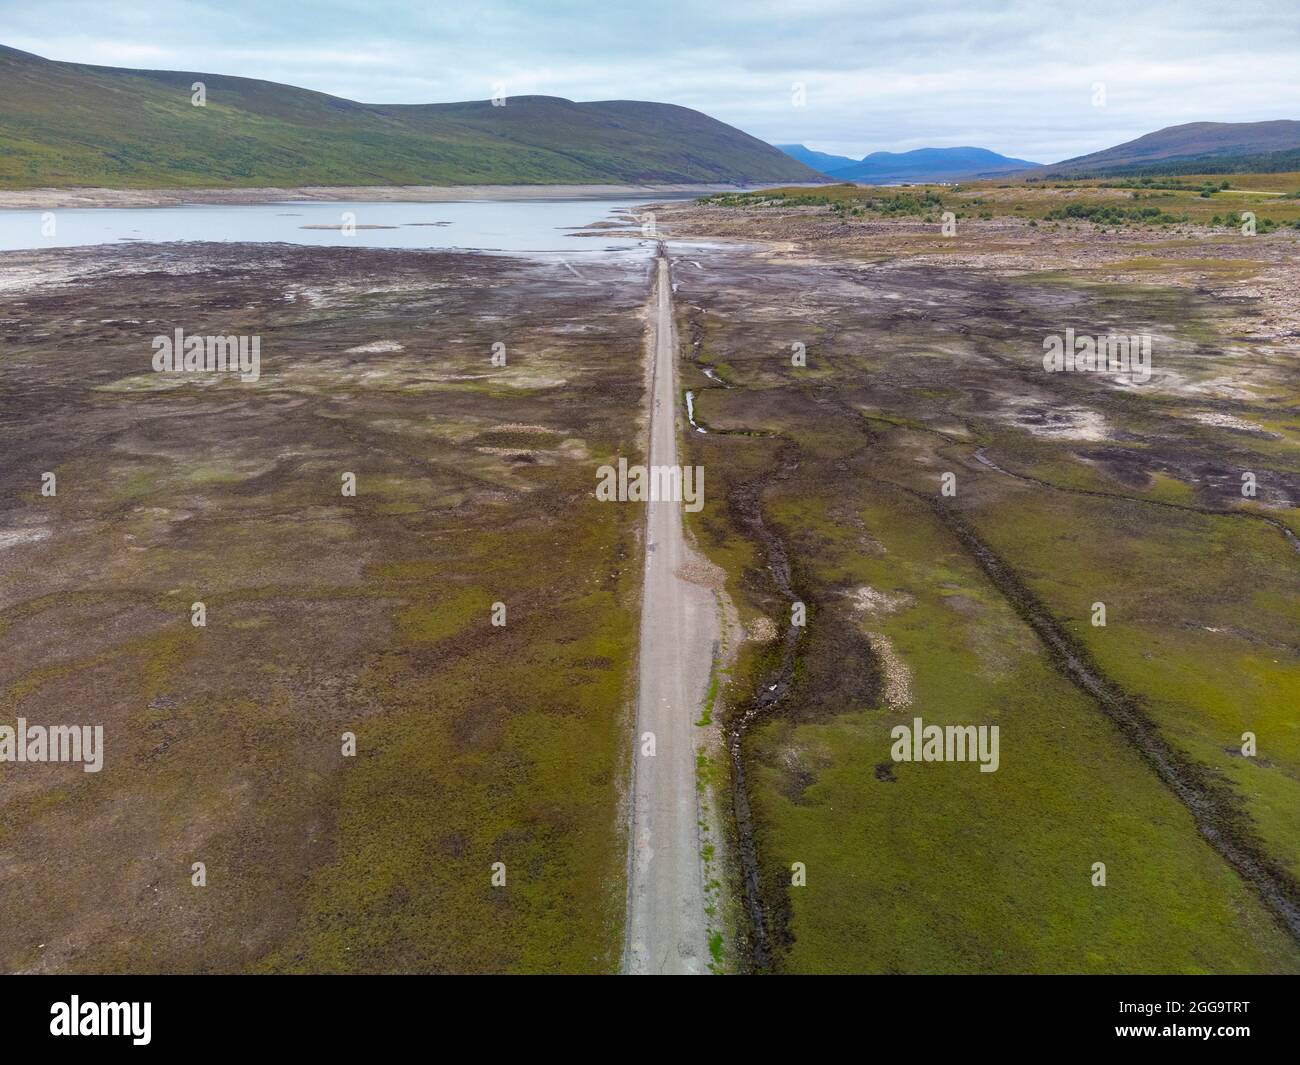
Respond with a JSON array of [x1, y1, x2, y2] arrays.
[[654, 204, 1300, 973]]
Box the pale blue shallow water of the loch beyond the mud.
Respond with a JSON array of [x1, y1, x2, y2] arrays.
[[0, 195, 666, 254]]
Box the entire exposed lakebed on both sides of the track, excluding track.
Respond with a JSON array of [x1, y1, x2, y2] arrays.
[[0, 196, 1300, 973]]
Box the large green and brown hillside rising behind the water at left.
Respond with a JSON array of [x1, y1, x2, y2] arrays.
[[0, 46, 819, 189]]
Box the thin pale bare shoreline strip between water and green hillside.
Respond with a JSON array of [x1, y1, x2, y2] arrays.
[[0, 185, 759, 211]]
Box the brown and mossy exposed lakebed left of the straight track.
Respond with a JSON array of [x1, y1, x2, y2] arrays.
[[0, 244, 649, 971]]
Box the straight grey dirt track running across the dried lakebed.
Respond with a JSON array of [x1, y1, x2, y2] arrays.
[[623, 248, 718, 974]]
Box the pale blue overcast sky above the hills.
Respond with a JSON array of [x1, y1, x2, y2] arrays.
[[0, 0, 1300, 163]]
